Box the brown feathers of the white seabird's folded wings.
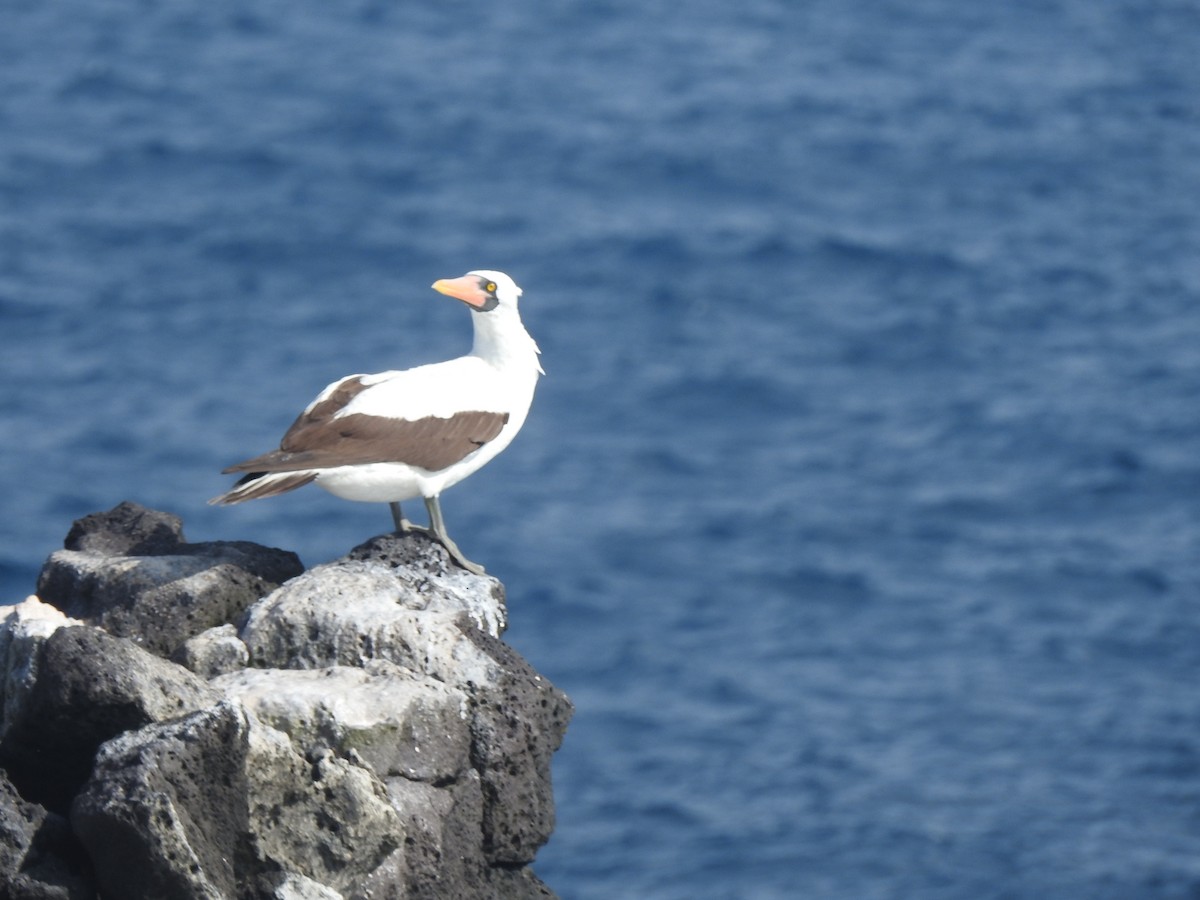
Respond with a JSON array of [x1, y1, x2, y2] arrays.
[[226, 376, 509, 473]]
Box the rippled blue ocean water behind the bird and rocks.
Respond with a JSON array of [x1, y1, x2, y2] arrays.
[[0, 0, 1200, 900]]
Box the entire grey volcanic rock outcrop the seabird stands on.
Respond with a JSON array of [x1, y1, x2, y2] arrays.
[[0, 504, 571, 900]]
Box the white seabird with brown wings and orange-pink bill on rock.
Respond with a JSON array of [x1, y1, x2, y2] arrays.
[[209, 269, 544, 574]]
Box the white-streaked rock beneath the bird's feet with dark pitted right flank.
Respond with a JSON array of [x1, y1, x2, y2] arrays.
[[241, 535, 571, 865]]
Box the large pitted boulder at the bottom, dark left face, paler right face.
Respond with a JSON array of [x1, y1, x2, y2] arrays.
[[71, 701, 403, 898]]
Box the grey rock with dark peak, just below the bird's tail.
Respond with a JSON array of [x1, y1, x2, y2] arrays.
[[37, 503, 304, 658]]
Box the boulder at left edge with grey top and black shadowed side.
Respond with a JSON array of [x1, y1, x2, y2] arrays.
[[0, 625, 220, 812]]
